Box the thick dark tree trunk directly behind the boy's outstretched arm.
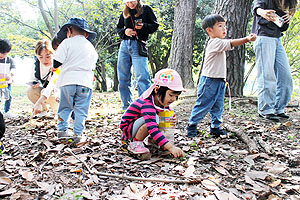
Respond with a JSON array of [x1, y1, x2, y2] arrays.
[[213, 0, 253, 96]]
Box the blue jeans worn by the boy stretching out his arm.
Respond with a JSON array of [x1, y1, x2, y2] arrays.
[[189, 76, 226, 128]]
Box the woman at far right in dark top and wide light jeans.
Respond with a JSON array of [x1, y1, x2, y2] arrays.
[[252, 0, 297, 122]]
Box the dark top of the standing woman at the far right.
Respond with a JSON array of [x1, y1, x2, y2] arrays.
[[251, 0, 289, 38]]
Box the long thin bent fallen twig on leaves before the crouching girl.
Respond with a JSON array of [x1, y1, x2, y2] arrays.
[[66, 149, 201, 184]]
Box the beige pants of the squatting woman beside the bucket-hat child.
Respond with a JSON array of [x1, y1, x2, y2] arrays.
[[26, 87, 59, 114]]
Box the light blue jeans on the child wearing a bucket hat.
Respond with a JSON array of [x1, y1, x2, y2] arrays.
[[57, 85, 93, 135]]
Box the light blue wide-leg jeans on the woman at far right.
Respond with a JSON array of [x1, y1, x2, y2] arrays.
[[254, 36, 293, 115]]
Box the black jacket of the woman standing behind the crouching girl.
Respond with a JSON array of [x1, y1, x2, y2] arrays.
[[117, 5, 158, 41]]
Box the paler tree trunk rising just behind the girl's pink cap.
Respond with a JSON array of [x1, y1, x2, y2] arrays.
[[169, 0, 197, 88]]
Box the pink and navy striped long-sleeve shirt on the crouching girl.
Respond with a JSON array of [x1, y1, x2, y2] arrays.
[[120, 96, 169, 146]]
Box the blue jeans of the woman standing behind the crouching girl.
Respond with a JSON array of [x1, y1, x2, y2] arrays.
[[117, 40, 151, 110]]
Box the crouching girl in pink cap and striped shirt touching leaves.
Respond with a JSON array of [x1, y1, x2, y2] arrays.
[[120, 69, 184, 157]]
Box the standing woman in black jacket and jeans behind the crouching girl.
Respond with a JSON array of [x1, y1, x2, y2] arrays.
[[117, 0, 158, 110]]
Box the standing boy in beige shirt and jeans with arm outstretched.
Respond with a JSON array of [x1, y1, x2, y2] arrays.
[[187, 14, 256, 137]]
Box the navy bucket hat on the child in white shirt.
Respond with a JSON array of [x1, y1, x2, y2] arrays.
[[57, 17, 97, 42]]
